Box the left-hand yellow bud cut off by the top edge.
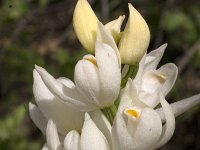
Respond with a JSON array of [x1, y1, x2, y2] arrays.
[[73, 0, 98, 53]]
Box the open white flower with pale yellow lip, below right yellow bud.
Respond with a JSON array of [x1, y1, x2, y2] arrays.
[[134, 44, 178, 108]]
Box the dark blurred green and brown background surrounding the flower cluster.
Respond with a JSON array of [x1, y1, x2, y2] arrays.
[[0, 0, 200, 150]]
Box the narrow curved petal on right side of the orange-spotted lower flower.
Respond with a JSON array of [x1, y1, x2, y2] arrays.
[[155, 94, 175, 148]]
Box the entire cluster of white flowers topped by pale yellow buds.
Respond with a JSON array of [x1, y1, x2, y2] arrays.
[[29, 0, 200, 150]]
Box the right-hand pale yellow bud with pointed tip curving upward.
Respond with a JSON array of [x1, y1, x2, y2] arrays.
[[119, 4, 150, 65]]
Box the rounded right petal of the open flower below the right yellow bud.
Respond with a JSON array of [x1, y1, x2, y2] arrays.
[[158, 63, 178, 96]]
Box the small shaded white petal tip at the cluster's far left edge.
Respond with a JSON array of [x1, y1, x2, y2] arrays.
[[29, 102, 47, 134]]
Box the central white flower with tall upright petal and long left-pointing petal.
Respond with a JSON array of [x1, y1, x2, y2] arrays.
[[35, 23, 121, 111]]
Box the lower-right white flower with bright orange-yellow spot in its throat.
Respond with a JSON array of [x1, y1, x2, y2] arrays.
[[112, 79, 175, 150]]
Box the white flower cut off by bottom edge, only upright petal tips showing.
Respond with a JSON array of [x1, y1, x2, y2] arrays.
[[43, 113, 110, 150]]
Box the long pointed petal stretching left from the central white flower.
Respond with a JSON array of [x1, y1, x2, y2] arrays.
[[35, 66, 94, 111]]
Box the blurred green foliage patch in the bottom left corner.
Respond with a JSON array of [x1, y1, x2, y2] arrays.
[[0, 105, 40, 150]]
